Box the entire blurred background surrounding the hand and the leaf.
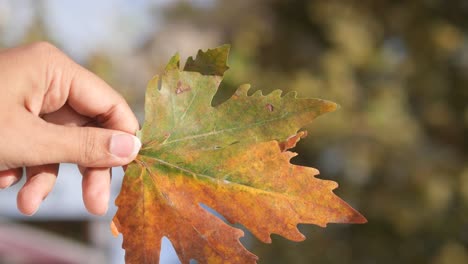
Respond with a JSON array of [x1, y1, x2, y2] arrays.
[[0, 0, 468, 264]]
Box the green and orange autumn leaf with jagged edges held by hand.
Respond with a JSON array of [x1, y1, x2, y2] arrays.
[[112, 45, 366, 263]]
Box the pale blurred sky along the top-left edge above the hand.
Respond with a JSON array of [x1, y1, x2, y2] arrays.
[[0, 0, 170, 61]]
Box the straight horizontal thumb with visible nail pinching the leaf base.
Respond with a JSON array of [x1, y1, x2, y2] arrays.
[[23, 117, 141, 167]]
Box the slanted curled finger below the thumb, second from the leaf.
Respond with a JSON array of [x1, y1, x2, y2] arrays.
[[17, 164, 59, 215]]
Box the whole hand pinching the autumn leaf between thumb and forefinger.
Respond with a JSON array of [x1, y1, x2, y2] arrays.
[[0, 43, 141, 215]]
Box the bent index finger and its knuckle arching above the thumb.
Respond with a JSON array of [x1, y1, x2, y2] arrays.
[[4, 42, 139, 134]]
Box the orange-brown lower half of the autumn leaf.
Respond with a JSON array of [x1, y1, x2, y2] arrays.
[[114, 133, 366, 263]]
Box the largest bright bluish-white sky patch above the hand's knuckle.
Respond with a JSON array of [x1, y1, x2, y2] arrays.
[[45, 0, 161, 60]]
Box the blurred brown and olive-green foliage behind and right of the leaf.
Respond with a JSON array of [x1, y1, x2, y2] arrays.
[[1, 0, 468, 264]]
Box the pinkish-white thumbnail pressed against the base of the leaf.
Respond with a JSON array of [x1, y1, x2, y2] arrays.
[[109, 134, 141, 158]]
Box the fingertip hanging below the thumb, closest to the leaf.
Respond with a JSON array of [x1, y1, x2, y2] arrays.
[[80, 168, 111, 215]]
